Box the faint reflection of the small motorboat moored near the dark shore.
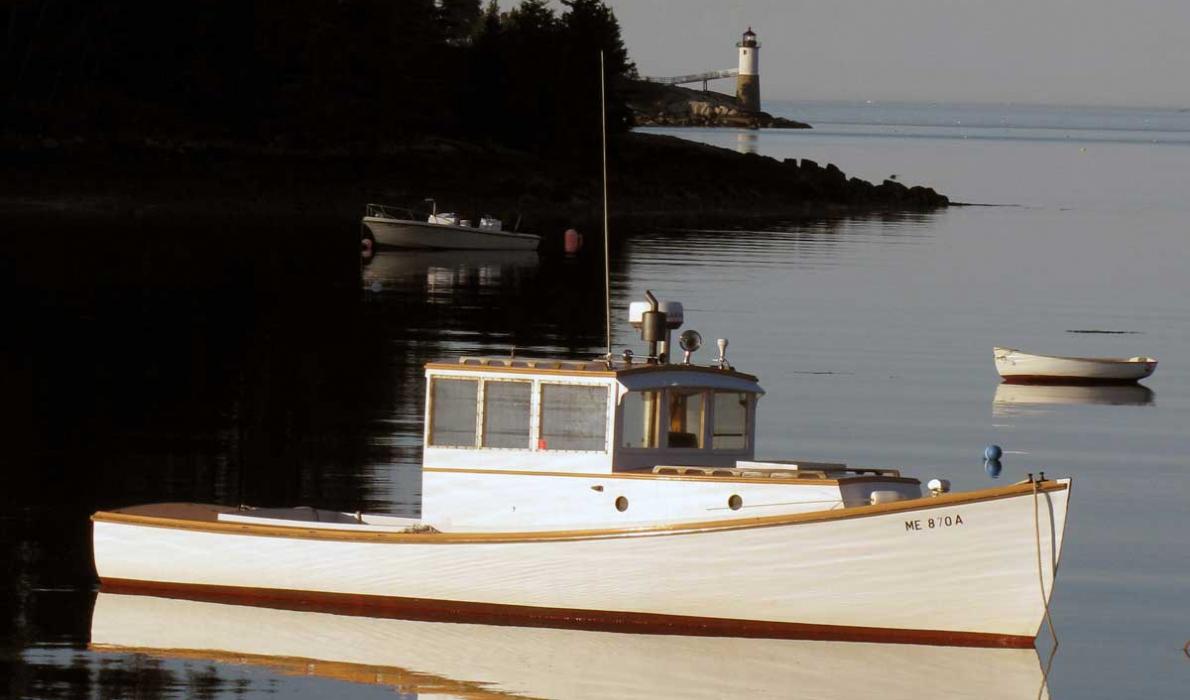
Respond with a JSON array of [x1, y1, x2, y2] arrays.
[[359, 250, 538, 295]]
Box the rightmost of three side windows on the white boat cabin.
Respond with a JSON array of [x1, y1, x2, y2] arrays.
[[538, 383, 607, 451]]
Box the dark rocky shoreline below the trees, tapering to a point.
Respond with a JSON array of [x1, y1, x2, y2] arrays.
[[0, 133, 948, 248]]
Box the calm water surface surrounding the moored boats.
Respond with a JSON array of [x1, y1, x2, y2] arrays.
[[0, 105, 1190, 699]]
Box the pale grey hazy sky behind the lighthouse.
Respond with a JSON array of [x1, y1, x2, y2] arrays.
[[599, 0, 1190, 107]]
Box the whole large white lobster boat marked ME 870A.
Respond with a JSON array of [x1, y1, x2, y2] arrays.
[[93, 294, 1070, 646]]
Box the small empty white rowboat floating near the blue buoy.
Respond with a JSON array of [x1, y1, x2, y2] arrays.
[[992, 348, 1157, 385]]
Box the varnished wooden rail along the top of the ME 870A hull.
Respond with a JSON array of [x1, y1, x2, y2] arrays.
[[90, 481, 1066, 544]]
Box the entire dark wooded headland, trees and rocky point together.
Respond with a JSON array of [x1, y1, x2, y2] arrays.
[[0, 0, 947, 232]]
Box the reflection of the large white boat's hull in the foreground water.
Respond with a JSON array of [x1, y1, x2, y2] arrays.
[[97, 592, 1048, 700]]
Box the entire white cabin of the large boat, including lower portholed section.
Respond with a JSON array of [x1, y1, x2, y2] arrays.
[[422, 357, 920, 531]]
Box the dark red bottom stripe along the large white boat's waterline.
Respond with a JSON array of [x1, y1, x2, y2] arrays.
[[101, 579, 1033, 649]]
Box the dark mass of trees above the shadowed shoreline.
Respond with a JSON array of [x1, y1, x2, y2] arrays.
[[0, 0, 635, 154]]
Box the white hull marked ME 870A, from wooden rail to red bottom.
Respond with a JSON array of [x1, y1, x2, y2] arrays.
[[94, 481, 1069, 646]]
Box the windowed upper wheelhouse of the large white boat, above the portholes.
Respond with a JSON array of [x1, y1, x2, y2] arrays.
[[422, 357, 764, 474]]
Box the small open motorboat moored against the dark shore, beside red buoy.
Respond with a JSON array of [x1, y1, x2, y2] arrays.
[[361, 200, 541, 250]]
